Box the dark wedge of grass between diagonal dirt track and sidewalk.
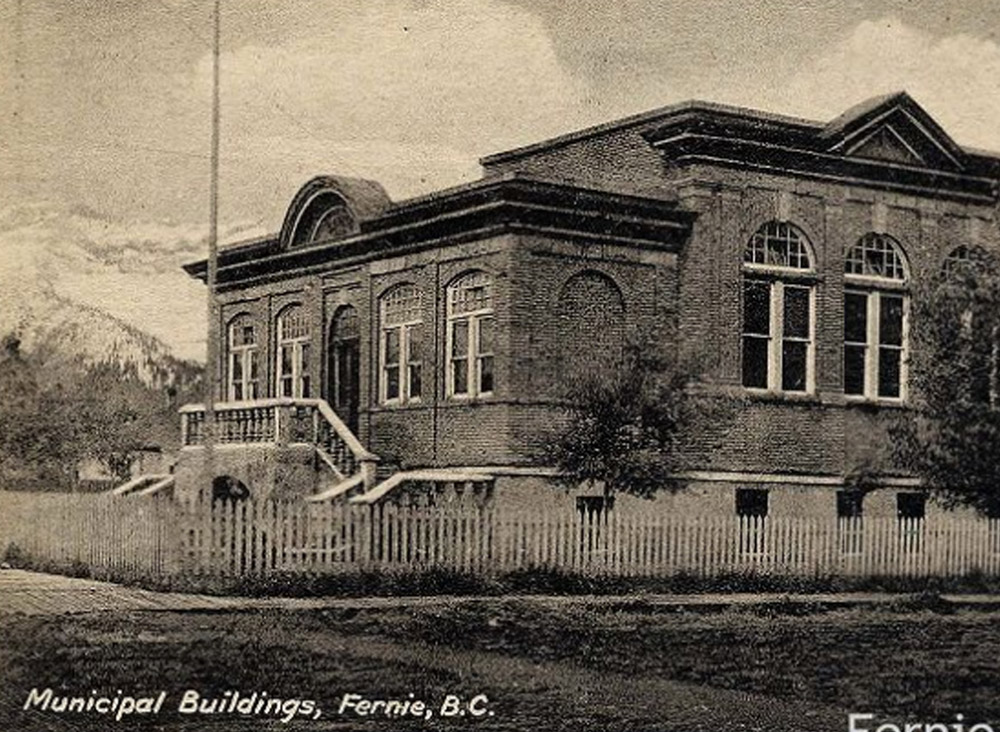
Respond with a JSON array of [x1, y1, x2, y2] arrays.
[[316, 594, 1000, 719]]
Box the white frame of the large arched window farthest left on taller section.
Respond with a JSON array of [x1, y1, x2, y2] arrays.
[[740, 221, 816, 396]]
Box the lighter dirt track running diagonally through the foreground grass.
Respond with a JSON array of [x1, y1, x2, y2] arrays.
[[254, 632, 847, 732]]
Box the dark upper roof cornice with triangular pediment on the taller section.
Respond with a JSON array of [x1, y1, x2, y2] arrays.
[[480, 92, 1000, 204]]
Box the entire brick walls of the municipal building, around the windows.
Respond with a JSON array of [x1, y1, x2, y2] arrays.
[[205, 137, 1000, 488]]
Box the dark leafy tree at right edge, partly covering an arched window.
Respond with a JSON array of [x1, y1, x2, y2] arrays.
[[892, 256, 1000, 515]]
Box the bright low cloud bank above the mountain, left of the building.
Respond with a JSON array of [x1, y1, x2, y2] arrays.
[[0, 203, 248, 359]]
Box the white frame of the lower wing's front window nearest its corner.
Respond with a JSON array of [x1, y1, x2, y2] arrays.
[[445, 271, 496, 399]]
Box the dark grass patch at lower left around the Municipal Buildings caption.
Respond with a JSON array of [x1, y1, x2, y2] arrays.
[[0, 612, 480, 732]]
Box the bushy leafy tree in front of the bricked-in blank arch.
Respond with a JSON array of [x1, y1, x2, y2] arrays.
[[534, 346, 705, 498]]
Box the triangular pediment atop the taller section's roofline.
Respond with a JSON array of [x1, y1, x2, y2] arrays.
[[822, 92, 965, 171]]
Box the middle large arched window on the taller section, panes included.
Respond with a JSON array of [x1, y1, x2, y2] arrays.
[[844, 233, 909, 401]]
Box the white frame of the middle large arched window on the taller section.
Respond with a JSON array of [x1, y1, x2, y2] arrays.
[[841, 234, 910, 404]]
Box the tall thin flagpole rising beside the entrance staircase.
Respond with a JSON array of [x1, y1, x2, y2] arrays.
[[204, 0, 221, 495]]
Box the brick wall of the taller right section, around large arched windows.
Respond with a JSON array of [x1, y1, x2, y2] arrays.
[[678, 167, 1000, 484]]
